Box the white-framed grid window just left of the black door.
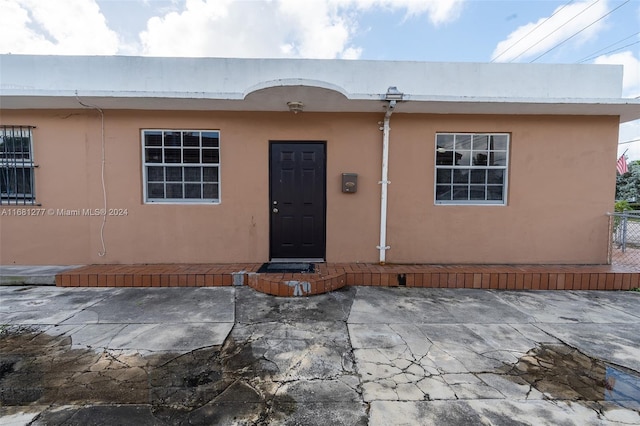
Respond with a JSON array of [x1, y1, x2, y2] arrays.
[[142, 130, 220, 203]]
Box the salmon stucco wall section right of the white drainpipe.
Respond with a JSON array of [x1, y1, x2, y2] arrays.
[[387, 115, 618, 264]]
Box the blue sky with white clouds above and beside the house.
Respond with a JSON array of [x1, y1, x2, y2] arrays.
[[0, 0, 640, 161]]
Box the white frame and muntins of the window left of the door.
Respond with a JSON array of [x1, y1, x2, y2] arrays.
[[140, 129, 221, 204]]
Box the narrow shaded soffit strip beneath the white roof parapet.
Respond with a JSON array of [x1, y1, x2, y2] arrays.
[[0, 93, 640, 123]]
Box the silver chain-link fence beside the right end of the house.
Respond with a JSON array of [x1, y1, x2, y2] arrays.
[[609, 211, 640, 270]]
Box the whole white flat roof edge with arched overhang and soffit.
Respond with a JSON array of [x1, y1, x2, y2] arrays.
[[0, 55, 640, 122]]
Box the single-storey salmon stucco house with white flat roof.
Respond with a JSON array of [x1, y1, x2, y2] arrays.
[[0, 55, 640, 265]]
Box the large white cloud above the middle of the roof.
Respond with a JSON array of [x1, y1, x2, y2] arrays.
[[140, 0, 464, 59]]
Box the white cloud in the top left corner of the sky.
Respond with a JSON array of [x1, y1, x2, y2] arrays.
[[0, 0, 119, 55]]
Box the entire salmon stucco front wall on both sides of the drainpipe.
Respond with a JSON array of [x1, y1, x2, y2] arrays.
[[0, 110, 618, 265]]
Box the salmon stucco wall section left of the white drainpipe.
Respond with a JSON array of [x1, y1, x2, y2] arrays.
[[0, 110, 381, 264]]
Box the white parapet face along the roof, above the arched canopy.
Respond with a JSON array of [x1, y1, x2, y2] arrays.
[[0, 55, 622, 98]]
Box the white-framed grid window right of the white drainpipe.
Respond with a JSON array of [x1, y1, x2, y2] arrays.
[[435, 133, 510, 205]]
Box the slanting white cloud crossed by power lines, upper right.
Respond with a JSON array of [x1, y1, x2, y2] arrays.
[[491, 0, 609, 62]]
